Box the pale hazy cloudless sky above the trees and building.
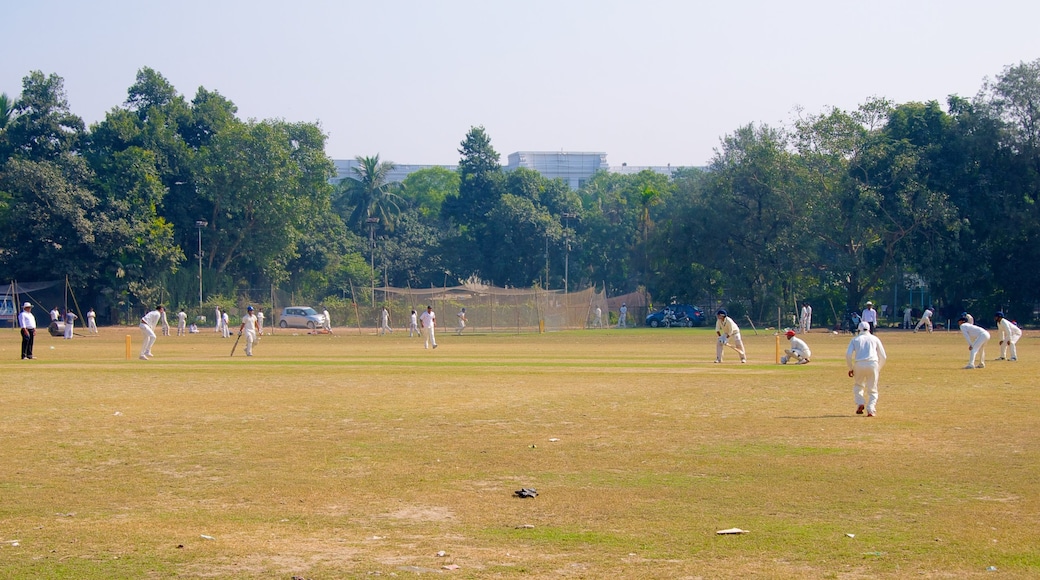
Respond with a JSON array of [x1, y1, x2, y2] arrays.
[[0, 0, 1040, 165]]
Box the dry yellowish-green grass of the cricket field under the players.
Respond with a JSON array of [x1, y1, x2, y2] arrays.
[[0, 327, 1040, 579]]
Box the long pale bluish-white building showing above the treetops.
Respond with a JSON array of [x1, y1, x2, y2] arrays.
[[333, 151, 683, 189]]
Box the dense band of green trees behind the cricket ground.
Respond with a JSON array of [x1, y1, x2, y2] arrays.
[[0, 59, 1040, 322]]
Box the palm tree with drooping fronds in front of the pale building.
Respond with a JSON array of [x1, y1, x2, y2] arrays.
[[335, 154, 401, 233]]
